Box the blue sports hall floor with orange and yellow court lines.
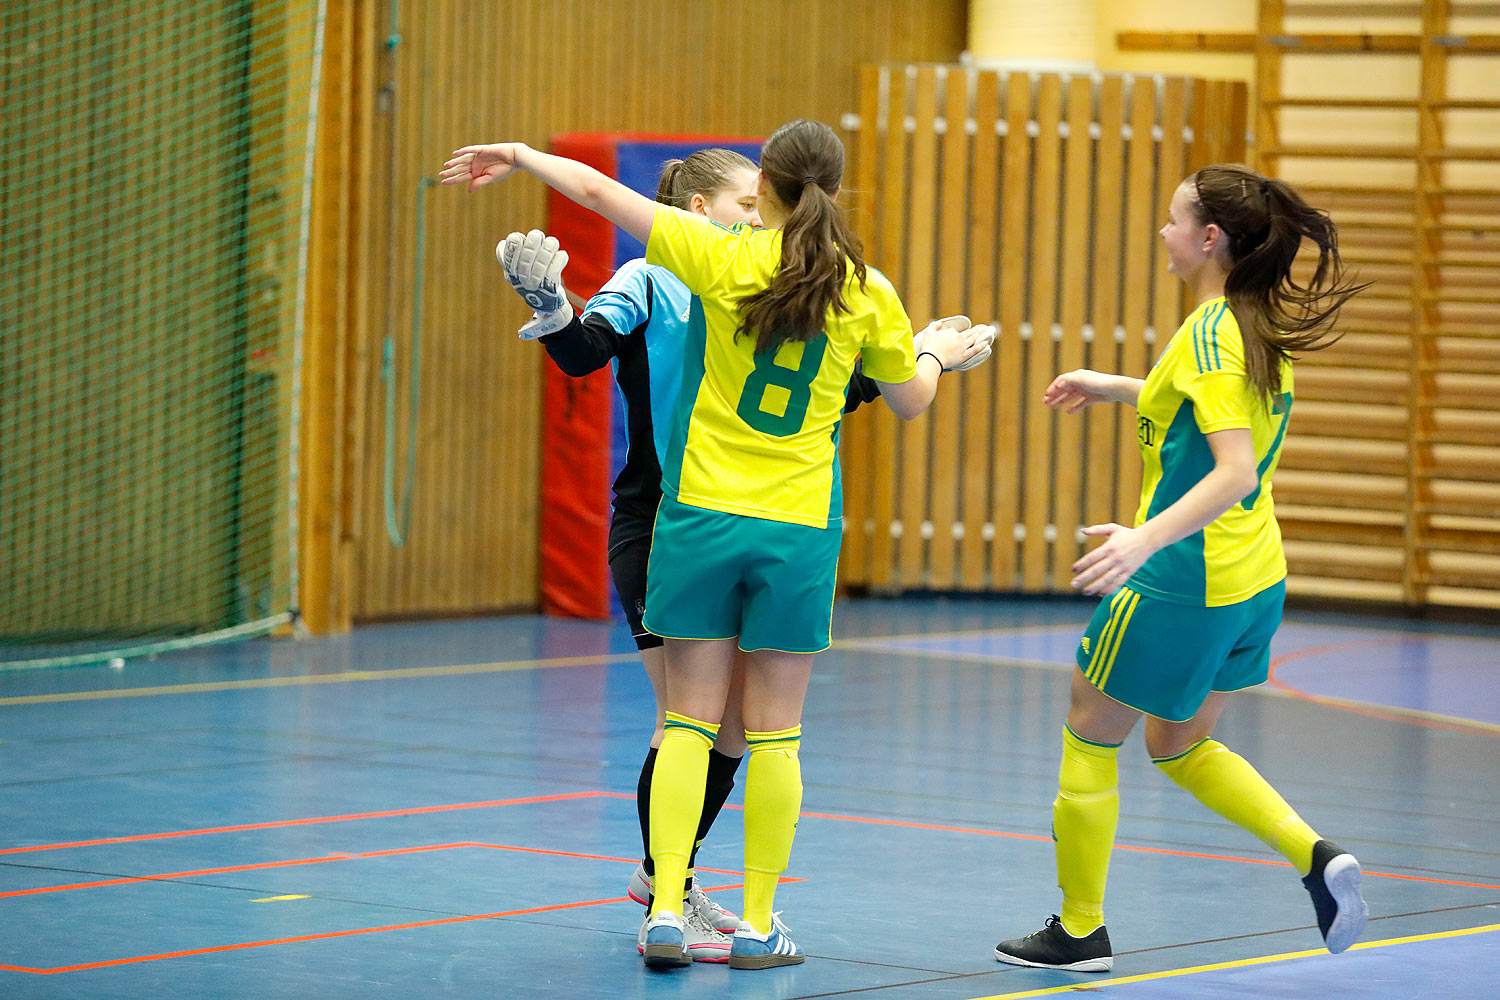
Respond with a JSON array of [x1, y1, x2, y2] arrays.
[[0, 598, 1500, 1000]]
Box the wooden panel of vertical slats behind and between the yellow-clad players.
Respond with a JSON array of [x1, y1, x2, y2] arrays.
[[843, 66, 1242, 592]]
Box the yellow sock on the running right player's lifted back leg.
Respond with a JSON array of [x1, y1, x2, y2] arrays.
[[1152, 739, 1317, 876]]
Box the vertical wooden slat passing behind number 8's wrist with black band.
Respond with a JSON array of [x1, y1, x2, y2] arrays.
[[897, 66, 938, 586]]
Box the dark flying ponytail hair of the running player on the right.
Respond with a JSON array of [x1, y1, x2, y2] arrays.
[[1188, 163, 1370, 396]]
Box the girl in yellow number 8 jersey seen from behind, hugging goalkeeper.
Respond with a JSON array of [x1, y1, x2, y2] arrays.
[[443, 121, 989, 969]]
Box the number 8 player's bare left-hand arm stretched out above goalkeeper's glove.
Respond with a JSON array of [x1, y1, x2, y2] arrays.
[[440, 142, 656, 243]]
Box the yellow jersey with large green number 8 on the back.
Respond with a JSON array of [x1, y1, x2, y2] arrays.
[[647, 205, 917, 528]]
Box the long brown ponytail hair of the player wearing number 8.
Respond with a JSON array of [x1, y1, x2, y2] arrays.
[[735, 118, 866, 354]]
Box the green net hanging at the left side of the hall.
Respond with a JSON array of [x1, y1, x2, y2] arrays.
[[0, 0, 320, 670]]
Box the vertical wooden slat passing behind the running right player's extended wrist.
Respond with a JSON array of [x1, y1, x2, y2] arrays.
[[1083, 76, 1128, 539]]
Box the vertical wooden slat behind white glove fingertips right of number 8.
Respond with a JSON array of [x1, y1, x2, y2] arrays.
[[959, 70, 1001, 591]]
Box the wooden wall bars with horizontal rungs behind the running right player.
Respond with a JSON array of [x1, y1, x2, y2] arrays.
[[1121, 0, 1500, 609]]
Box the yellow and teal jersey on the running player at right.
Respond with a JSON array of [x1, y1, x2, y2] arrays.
[[1130, 297, 1293, 607]]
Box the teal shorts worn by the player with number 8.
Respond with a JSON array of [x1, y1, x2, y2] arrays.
[[644, 496, 843, 652]]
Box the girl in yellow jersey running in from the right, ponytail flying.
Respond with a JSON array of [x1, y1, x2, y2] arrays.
[[995, 165, 1367, 972]]
